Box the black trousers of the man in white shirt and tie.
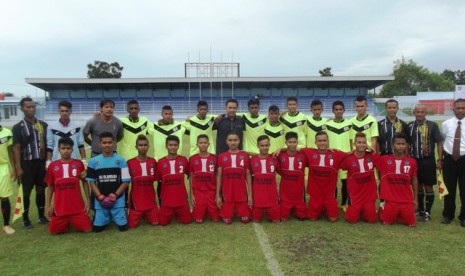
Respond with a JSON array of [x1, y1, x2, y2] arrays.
[[442, 153, 465, 220]]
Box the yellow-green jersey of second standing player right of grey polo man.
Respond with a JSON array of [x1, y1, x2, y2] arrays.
[[151, 121, 185, 161]]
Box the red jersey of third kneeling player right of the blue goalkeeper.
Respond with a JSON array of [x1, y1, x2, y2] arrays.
[[189, 154, 216, 191]]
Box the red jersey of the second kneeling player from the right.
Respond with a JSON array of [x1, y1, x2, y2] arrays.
[[341, 153, 380, 205]]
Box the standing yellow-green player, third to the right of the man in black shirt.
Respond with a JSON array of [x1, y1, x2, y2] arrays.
[[279, 97, 307, 148]]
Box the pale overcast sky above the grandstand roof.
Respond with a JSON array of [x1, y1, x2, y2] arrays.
[[0, 0, 465, 96]]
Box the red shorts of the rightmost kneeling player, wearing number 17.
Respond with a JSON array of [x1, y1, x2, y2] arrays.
[[379, 201, 416, 227]]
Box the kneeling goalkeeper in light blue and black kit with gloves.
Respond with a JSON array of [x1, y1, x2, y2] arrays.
[[86, 132, 131, 232]]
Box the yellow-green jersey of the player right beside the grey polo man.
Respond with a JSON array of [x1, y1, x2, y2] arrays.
[[118, 116, 153, 160]]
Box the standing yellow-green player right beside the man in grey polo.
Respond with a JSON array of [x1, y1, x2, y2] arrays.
[[118, 100, 153, 160]]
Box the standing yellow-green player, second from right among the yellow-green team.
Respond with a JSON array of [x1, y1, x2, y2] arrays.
[[326, 101, 352, 210]]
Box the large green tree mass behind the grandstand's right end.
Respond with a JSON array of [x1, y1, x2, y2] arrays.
[[379, 57, 454, 98]]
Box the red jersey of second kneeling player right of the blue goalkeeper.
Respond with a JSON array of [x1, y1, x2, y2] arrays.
[[156, 156, 189, 208]]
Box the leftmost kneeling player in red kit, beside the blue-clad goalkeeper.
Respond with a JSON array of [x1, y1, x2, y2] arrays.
[[45, 137, 92, 234]]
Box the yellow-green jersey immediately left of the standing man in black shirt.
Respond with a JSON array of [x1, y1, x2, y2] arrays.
[[183, 115, 216, 156]]
